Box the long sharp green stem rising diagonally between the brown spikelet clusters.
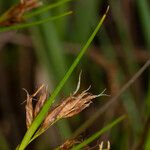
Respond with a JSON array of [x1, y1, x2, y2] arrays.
[[18, 6, 108, 150]]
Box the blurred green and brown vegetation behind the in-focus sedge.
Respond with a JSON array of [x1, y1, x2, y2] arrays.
[[0, 0, 150, 150]]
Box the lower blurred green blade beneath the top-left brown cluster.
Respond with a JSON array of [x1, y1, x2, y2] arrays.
[[0, 11, 72, 32]]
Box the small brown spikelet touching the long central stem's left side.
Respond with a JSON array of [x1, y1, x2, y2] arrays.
[[34, 86, 47, 117]]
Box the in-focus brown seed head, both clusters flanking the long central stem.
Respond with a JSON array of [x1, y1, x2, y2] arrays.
[[23, 73, 106, 139]]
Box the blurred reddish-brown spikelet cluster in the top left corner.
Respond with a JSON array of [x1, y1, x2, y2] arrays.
[[0, 0, 42, 26]]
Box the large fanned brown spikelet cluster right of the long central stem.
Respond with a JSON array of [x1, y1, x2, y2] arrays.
[[40, 89, 105, 130]]
